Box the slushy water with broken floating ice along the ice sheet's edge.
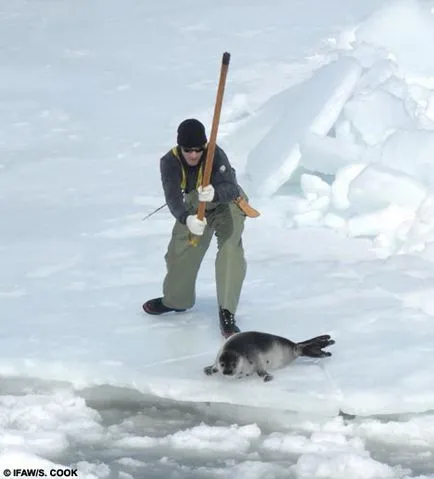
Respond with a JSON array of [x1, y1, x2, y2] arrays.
[[0, 378, 434, 479]]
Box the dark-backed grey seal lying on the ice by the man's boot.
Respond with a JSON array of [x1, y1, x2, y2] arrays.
[[204, 331, 335, 381]]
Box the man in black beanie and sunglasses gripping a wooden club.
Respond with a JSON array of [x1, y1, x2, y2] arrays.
[[143, 119, 246, 337]]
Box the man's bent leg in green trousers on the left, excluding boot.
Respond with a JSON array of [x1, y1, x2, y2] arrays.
[[163, 221, 213, 309]]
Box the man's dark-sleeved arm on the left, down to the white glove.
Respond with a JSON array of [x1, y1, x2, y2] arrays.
[[160, 152, 188, 224]]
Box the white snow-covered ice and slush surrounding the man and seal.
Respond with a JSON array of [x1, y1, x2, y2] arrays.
[[0, 0, 434, 479]]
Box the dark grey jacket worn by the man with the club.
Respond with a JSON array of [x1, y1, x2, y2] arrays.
[[160, 145, 240, 224]]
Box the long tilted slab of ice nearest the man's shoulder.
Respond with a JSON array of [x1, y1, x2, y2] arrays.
[[246, 57, 361, 196]]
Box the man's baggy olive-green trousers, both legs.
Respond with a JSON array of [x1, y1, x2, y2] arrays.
[[163, 196, 246, 314]]
